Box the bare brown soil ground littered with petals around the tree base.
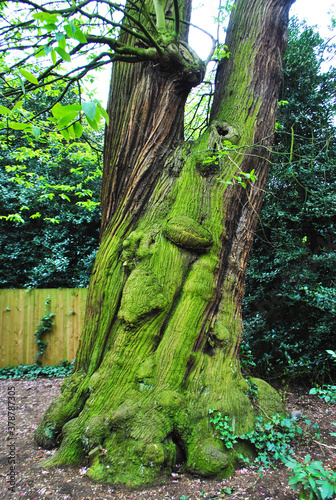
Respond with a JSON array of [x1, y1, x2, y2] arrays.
[[0, 379, 336, 500]]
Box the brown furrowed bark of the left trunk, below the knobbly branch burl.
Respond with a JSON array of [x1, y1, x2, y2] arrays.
[[102, 63, 187, 233]]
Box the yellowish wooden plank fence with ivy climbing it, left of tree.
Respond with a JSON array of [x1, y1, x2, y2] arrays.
[[0, 288, 87, 368]]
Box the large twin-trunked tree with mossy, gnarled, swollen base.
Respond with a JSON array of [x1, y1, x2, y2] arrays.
[[36, 0, 293, 486]]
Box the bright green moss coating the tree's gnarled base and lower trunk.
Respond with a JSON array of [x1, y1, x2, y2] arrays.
[[37, 0, 288, 486]]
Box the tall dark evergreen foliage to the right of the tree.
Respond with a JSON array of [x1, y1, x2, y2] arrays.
[[243, 20, 336, 381]]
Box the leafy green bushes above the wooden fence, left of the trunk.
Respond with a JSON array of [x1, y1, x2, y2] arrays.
[[0, 88, 101, 288]]
